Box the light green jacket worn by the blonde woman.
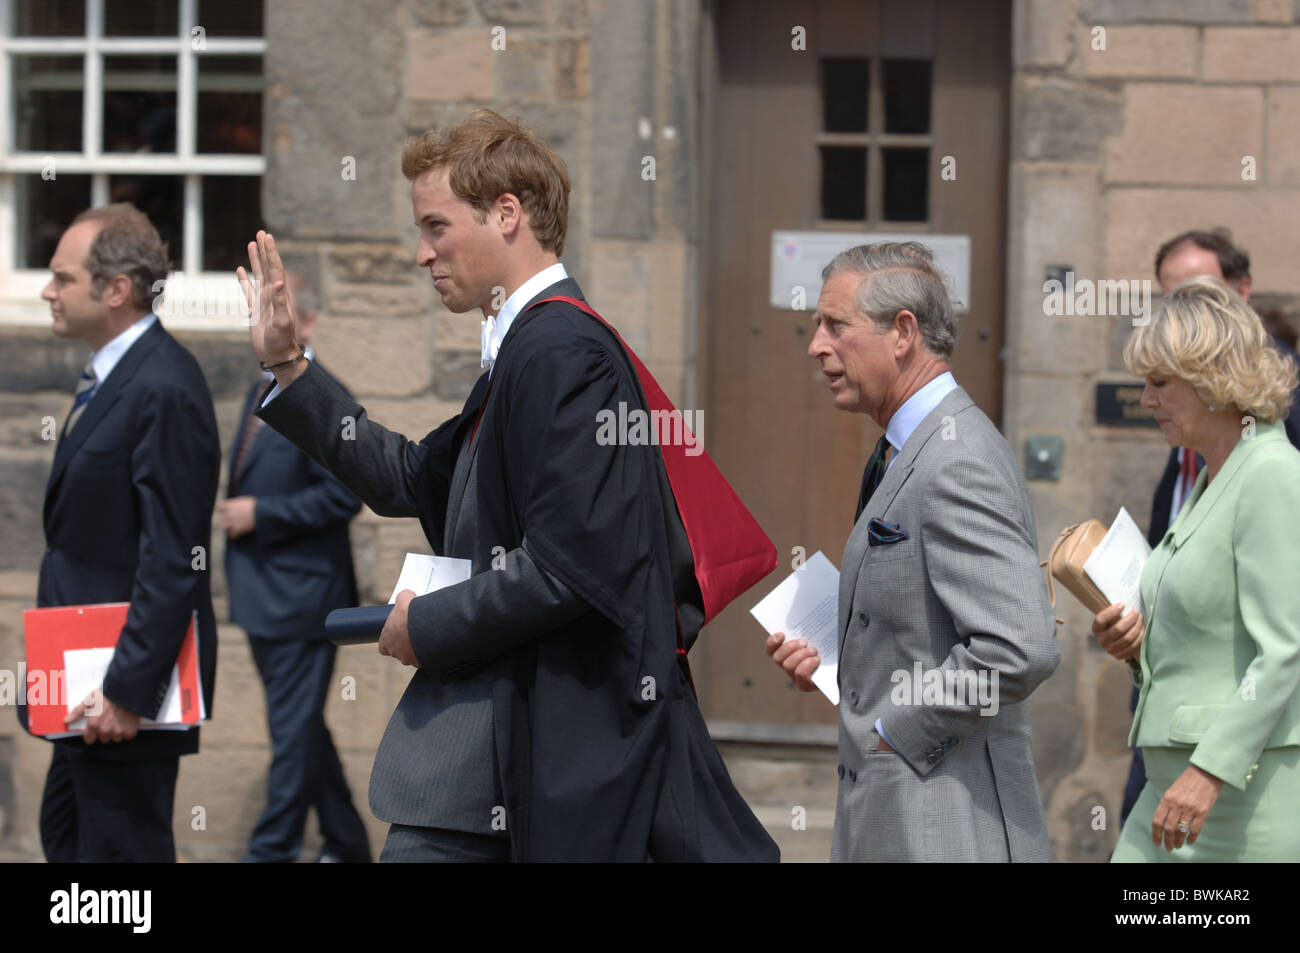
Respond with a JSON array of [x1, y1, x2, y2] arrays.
[[1128, 423, 1300, 790]]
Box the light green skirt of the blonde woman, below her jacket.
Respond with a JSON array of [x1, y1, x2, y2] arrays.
[[1110, 746, 1300, 863]]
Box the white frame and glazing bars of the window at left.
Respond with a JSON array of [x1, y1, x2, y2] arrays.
[[0, 0, 267, 330]]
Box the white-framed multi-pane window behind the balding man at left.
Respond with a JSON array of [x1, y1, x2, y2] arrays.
[[0, 0, 267, 324]]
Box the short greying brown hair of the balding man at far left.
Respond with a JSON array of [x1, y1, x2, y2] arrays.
[[73, 202, 168, 311]]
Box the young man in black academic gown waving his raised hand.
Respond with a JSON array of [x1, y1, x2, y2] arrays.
[[241, 111, 777, 861]]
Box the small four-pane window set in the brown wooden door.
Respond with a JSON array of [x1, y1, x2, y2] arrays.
[[816, 56, 933, 226]]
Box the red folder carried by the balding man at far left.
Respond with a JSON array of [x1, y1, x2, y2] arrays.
[[22, 602, 204, 735]]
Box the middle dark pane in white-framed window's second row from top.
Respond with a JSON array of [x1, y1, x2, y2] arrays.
[[103, 56, 176, 153]]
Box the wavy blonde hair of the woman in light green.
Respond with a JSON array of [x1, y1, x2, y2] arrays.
[[1125, 277, 1296, 424]]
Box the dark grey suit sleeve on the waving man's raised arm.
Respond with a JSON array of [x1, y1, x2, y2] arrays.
[[256, 361, 428, 516]]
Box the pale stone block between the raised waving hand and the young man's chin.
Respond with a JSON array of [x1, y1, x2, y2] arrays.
[[316, 316, 433, 403]]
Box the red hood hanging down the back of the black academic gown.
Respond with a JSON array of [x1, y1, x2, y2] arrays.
[[537, 295, 776, 623]]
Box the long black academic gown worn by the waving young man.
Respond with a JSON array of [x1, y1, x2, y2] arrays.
[[421, 282, 779, 861]]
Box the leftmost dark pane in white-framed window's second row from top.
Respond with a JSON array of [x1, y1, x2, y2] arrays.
[[13, 55, 85, 152]]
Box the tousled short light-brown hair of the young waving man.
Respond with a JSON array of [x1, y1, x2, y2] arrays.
[[402, 109, 569, 256]]
